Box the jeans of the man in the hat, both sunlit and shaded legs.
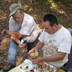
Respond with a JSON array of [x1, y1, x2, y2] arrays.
[[8, 38, 38, 63]]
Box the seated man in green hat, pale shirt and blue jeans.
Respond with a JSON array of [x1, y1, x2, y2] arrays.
[[1, 4, 39, 72]]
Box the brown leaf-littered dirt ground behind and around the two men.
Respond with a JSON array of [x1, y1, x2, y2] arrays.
[[0, 0, 72, 69]]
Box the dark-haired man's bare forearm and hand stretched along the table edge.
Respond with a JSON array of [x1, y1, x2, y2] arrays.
[[32, 52, 66, 64]]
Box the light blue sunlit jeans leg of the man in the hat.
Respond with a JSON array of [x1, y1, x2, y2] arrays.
[[8, 39, 18, 63]]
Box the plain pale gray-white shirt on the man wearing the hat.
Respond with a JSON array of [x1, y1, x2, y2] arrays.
[[9, 13, 39, 43]]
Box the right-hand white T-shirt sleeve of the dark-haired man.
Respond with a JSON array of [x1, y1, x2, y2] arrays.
[[58, 33, 71, 53]]
